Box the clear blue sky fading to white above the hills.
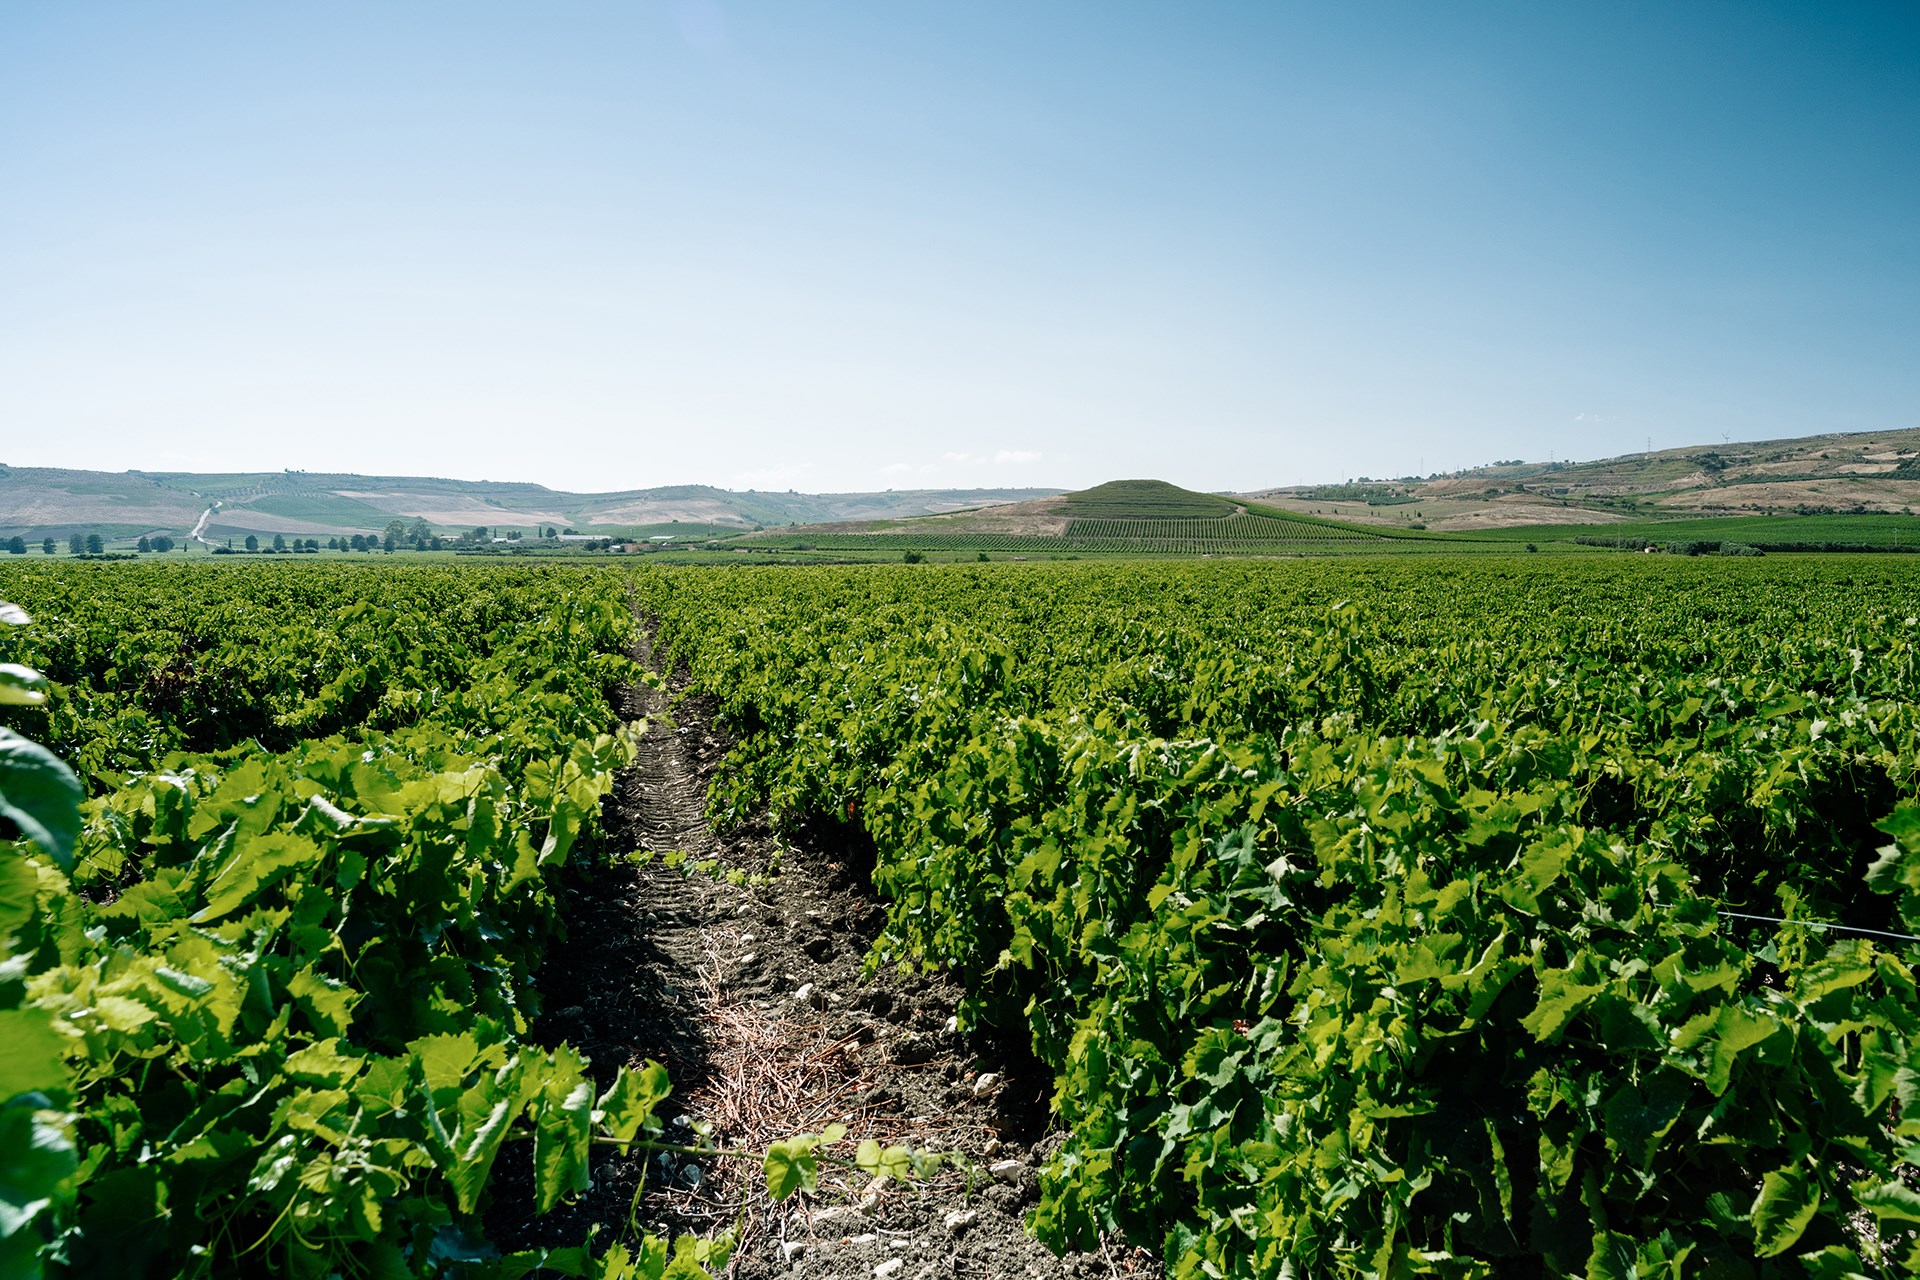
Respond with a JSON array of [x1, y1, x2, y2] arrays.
[[0, 0, 1920, 491]]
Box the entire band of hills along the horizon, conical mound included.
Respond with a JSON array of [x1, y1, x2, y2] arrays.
[[15, 430, 1920, 555]]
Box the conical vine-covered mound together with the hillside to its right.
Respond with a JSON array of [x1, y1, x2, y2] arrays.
[[720, 460, 1920, 557]]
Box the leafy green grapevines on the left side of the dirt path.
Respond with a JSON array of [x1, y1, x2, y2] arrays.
[[0, 566, 706, 1278]]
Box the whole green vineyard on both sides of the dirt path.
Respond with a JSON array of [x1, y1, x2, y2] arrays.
[[11, 555, 1920, 1280]]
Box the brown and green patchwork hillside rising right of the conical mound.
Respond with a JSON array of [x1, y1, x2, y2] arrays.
[[1244, 428, 1920, 532]]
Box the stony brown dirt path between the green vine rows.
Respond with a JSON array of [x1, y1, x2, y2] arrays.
[[490, 621, 1160, 1280]]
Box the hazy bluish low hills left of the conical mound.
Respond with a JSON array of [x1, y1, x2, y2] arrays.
[[0, 466, 1058, 537]]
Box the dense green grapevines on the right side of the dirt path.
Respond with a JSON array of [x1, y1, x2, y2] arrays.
[[639, 558, 1920, 1280]]
